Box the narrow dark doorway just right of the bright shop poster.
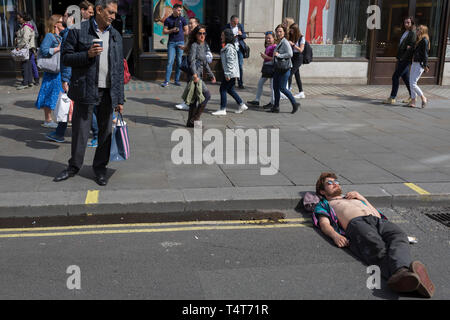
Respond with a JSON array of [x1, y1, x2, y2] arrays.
[[204, 0, 228, 53]]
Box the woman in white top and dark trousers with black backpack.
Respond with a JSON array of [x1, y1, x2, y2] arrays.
[[288, 23, 306, 99]]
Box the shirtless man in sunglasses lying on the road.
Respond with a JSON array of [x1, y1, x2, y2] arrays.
[[313, 173, 435, 298]]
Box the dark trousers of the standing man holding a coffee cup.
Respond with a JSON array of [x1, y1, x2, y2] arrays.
[[69, 89, 113, 174]]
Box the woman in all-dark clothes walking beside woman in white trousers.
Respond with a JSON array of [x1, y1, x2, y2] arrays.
[[383, 17, 416, 104]]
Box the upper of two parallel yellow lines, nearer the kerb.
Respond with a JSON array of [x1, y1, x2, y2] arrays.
[[0, 218, 310, 232]]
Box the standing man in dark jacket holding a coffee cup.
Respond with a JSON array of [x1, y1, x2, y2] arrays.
[[54, 0, 124, 186]]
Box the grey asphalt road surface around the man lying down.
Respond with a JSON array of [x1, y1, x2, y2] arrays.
[[0, 208, 450, 300]]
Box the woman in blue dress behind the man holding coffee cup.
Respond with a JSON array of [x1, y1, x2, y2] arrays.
[[36, 14, 64, 128]]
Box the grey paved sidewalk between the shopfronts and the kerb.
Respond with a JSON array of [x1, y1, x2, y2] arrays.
[[0, 82, 450, 218]]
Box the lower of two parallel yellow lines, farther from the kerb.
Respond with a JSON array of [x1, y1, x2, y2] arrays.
[[0, 223, 312, 238]]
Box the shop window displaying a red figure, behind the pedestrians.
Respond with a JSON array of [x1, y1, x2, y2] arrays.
[[283, 0, 369, 58]]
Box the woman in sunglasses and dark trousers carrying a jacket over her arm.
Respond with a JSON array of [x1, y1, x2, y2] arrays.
[[183, 25, 216, 128]]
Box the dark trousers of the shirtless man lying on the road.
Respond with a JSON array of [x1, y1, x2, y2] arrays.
[[346, 216, 412, 279]]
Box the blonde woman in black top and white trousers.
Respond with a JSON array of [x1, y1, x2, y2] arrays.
[[408, 25, 430, 108]]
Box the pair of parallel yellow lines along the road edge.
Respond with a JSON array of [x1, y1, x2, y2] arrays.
[[0, 218, 312, 238]]
